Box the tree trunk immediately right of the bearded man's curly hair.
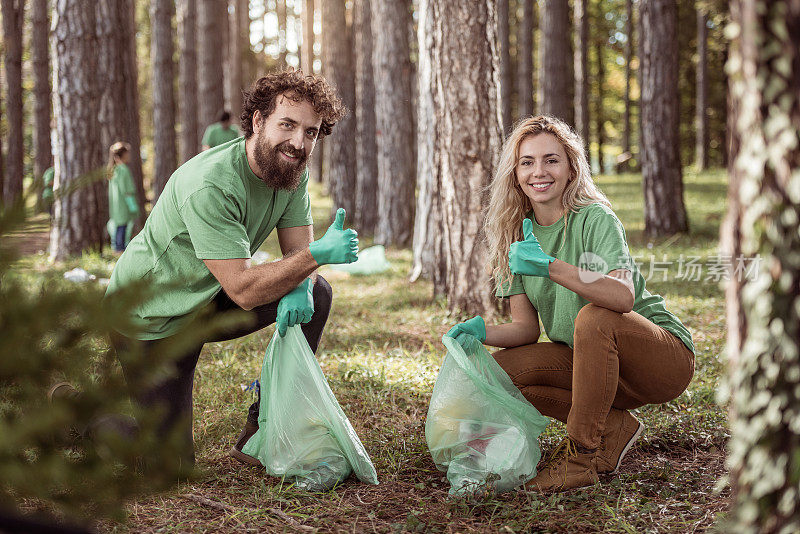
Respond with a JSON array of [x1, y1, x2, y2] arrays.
[[322, 0, 356, 217]]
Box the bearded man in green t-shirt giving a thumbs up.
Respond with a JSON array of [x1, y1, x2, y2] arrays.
[[106, 69, 358, 463]]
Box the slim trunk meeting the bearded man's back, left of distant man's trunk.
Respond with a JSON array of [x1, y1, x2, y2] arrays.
[[177, 0, 200, 163]]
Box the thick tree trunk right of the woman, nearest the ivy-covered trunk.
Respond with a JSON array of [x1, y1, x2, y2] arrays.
[[639, 0, 688, 237]]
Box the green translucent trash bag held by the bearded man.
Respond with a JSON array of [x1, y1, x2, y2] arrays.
[[242, 325, 378, 491]]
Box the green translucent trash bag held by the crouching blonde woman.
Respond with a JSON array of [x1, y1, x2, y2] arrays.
[[425, 335, 550, 495]]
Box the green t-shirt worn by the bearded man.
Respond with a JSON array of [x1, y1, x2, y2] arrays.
[[106, 138, 312, 339]]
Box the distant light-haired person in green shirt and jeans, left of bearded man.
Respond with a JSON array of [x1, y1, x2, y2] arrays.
[[108, 141, 139, 252]]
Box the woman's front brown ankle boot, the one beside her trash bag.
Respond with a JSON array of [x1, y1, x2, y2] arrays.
[[525, 437, 598, 493]]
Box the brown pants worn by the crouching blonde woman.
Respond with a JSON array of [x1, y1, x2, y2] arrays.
[[494, 304, 694, 449]]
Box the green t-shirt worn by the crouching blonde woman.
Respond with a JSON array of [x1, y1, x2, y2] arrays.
[[496, 203, 694, 352]]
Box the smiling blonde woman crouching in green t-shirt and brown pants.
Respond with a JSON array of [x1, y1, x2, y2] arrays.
[[448, 116, 694, 491]]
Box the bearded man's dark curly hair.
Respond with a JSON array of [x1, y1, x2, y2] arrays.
[[241, 67, 347, 139]]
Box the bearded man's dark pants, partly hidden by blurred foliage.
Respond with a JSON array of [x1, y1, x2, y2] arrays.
[[111, 276, 333, 462]]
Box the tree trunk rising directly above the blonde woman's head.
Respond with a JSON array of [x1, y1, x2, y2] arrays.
[[539, 0, 575, 126]]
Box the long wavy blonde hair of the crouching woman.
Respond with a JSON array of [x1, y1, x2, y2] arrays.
[[484, 115, 611, 294]]
